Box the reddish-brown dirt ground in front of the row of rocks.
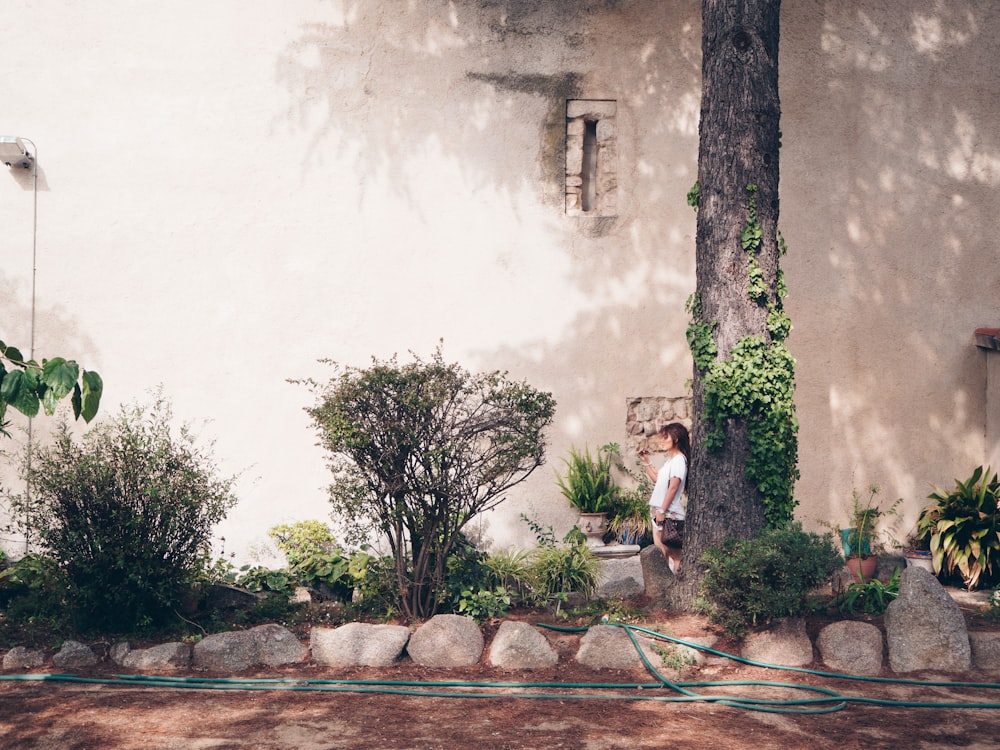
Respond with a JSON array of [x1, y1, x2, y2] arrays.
[[0, 613, 1000, 750]]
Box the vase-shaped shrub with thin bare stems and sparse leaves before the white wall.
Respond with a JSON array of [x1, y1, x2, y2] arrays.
[[303, 349, 555, 618]]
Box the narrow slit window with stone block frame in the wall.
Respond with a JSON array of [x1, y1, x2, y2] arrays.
[[566, 99, 618, 216]]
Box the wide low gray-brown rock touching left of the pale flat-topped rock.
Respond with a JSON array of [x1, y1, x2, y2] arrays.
[[192, 624, 308, 672]]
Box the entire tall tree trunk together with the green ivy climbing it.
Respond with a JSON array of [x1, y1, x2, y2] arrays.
[[671, 0, 796, 604]]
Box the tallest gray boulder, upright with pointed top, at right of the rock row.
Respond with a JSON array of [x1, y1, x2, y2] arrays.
[[884, 567, 972, 672]]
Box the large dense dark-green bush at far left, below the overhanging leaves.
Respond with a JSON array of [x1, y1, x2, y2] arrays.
[[13, 399, 236, 630]]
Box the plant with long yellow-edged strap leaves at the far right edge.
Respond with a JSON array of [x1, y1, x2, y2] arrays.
[[917, 466, 1000, 590]]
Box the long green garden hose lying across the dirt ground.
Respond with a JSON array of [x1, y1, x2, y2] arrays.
[[0, 623, 1000, 714]]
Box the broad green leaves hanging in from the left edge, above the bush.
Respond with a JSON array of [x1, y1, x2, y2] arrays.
[[0, 341, 104, 436]]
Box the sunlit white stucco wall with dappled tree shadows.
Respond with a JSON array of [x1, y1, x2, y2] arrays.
[[0, 0, 1000, 558]]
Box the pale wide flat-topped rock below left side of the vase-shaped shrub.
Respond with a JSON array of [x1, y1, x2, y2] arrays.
[[309, 622, 410, 667]]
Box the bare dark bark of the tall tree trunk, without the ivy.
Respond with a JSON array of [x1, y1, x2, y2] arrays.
[[671, 0, 780, 605]]
